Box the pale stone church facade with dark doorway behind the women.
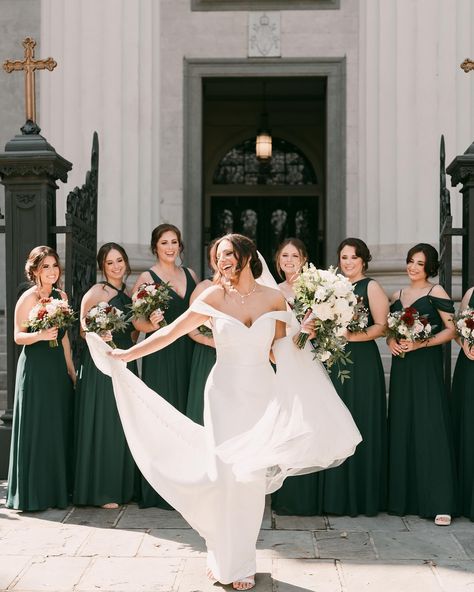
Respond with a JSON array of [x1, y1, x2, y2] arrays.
[[0, 0, 474, 306]]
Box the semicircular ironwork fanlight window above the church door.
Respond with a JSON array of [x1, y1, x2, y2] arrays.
[[213, 138, 318, 186]]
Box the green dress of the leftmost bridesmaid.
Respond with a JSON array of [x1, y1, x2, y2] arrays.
[[6, 289, 73, 512]]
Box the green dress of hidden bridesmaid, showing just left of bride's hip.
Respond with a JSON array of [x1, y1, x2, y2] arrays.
[[186, 343, 216, 425]]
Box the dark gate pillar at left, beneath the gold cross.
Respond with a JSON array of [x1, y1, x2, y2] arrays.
[[0, 121, 72, 479]]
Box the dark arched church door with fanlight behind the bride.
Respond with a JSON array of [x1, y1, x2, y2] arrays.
[[206, 137, 324, 271]]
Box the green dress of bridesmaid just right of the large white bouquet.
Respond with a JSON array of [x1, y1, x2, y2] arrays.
[[322, 278, 387, 516]]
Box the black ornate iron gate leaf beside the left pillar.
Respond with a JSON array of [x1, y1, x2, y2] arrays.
[[66, 132, 99, 361]]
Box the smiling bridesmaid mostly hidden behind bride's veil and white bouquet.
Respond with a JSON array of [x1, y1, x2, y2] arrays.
[[272, 237, 322, 516]]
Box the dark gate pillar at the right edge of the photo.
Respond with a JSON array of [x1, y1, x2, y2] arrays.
[[446, 142, 474, 294]]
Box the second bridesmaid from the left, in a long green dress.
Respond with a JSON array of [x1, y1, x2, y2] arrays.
[[73, 243, 137, 509]]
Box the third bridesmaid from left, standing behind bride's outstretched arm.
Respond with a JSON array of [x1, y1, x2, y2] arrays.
[[133, 224, 197, 509]]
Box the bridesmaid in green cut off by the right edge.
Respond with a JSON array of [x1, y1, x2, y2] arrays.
[[451, 288, 474, 521]]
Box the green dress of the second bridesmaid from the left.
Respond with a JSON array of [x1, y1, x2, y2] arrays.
[[73, 282, 137, 506]]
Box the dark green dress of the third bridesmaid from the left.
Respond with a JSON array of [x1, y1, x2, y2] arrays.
[[138, 267, 196, 510]]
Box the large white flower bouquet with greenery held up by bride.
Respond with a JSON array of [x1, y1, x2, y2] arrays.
[[294, 263, 357, 382]]
